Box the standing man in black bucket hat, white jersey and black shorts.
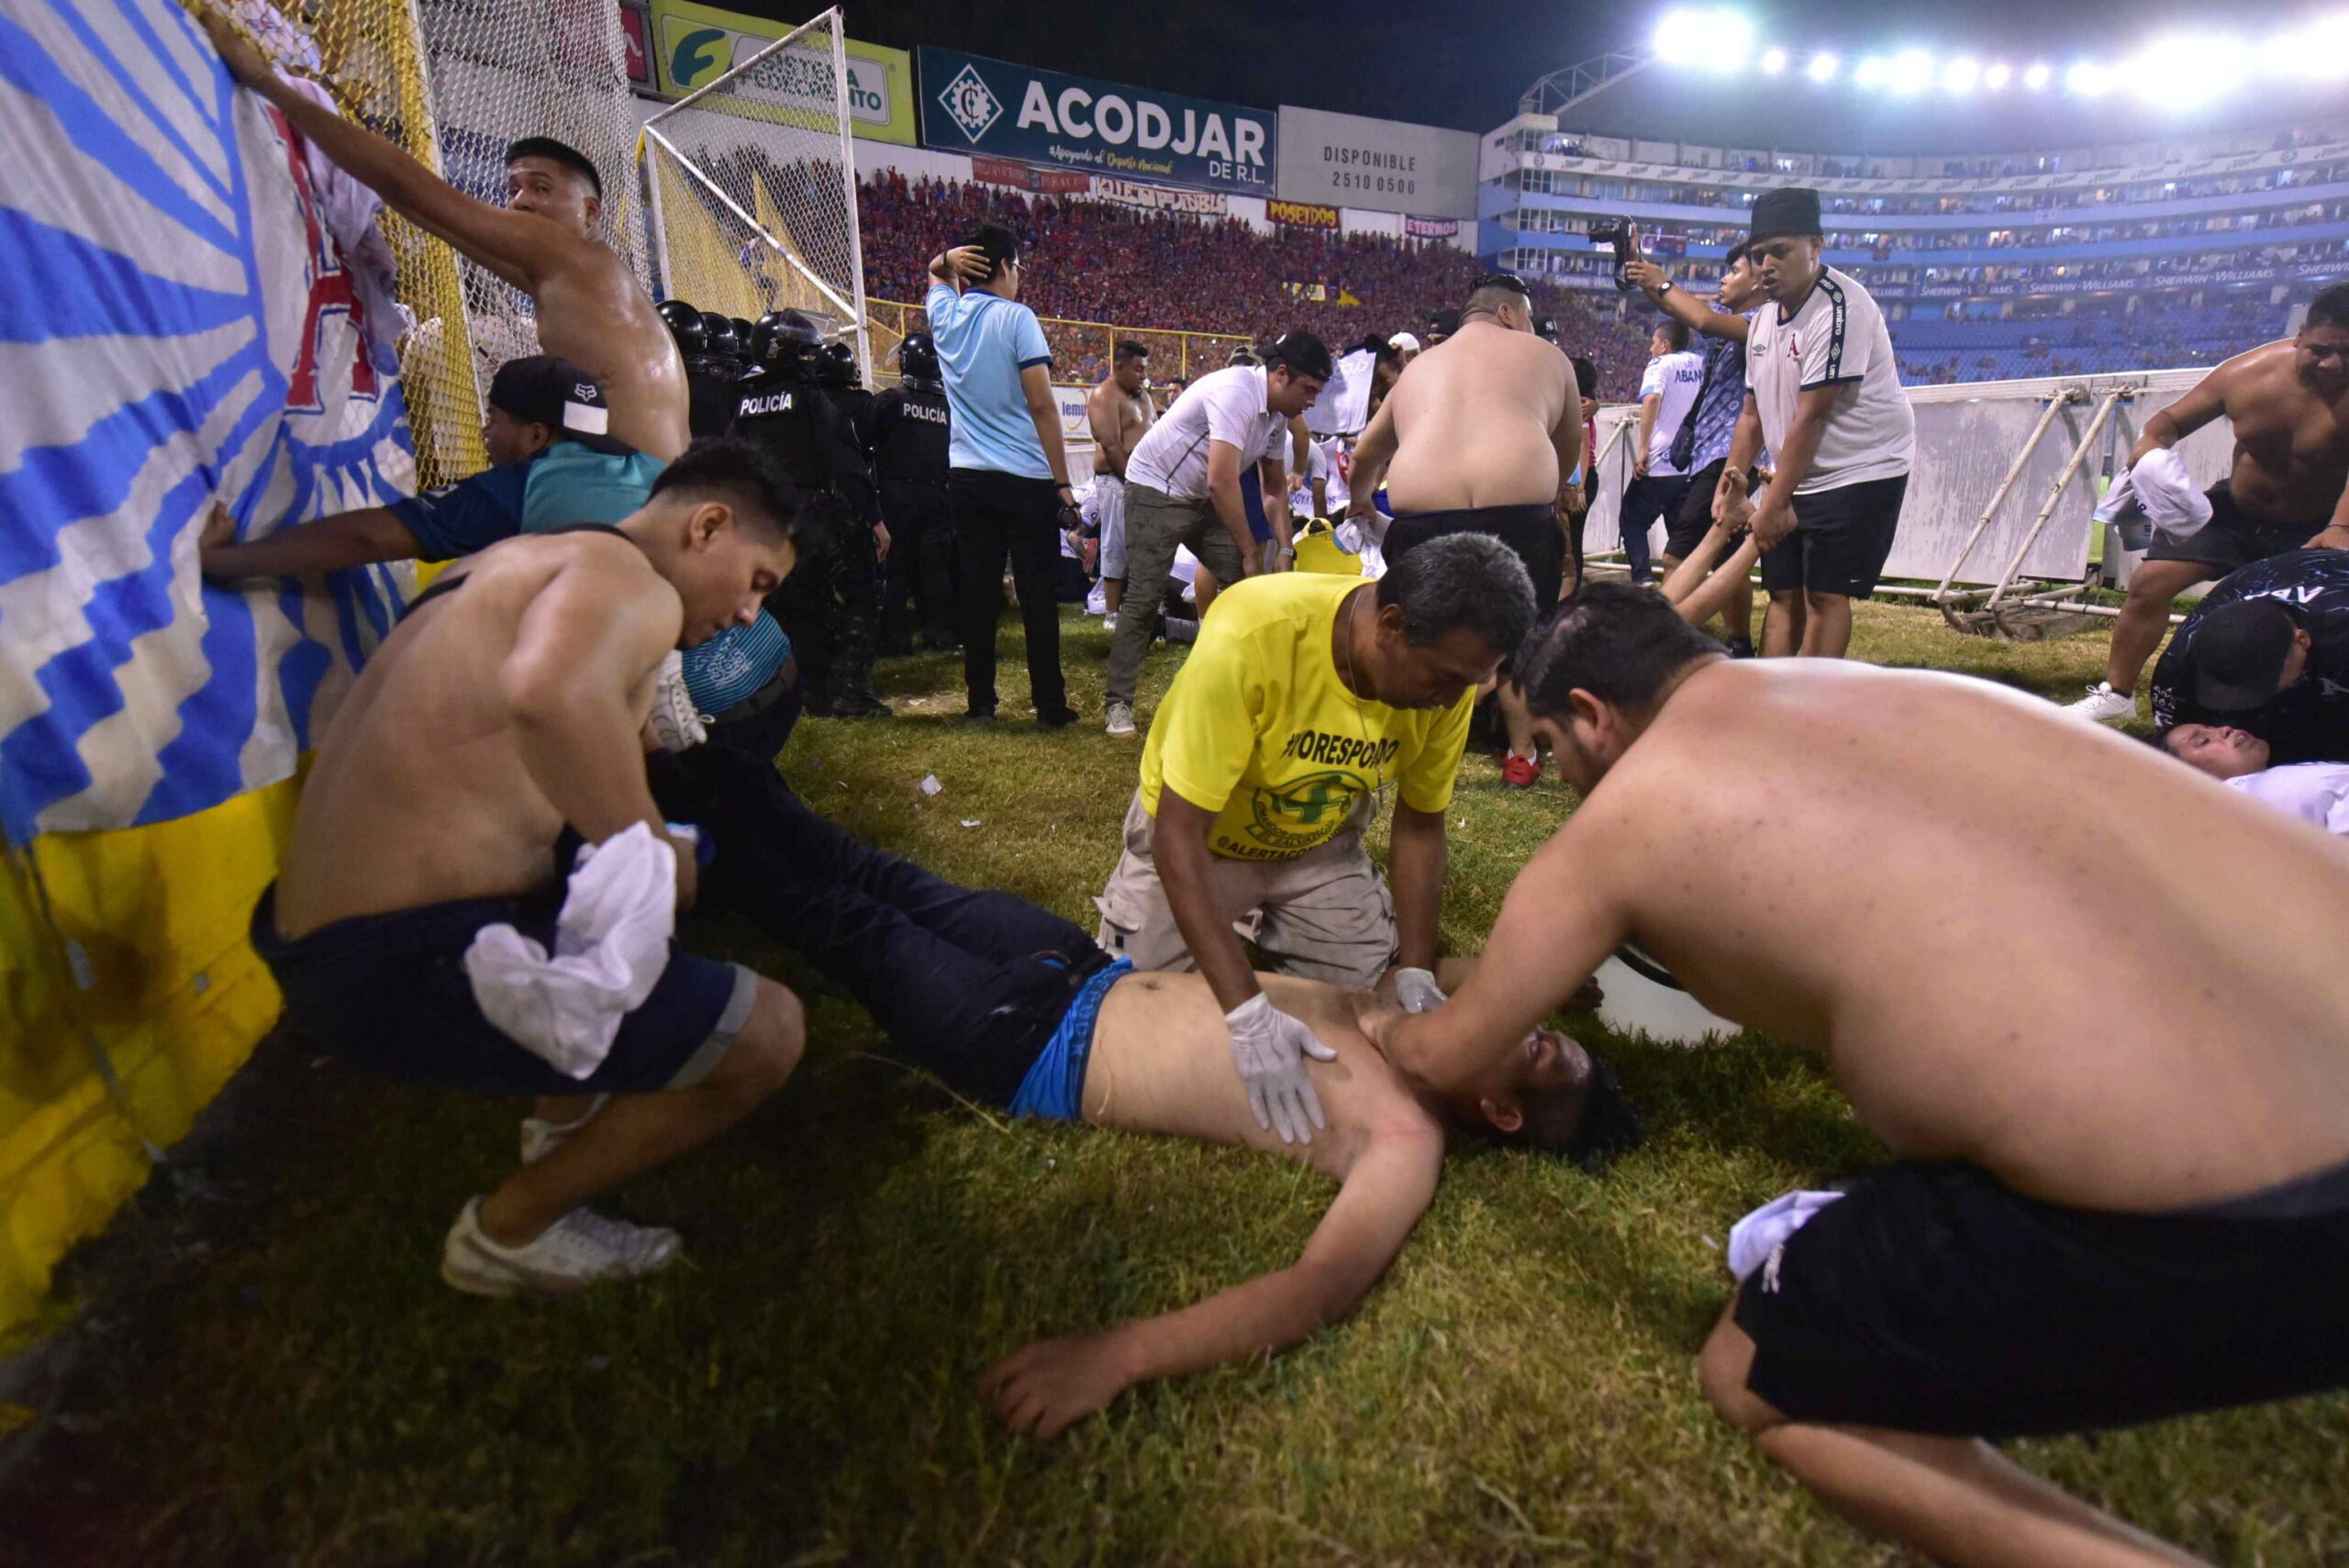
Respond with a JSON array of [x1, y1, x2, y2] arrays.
[[1729, 188, 1917, 660]]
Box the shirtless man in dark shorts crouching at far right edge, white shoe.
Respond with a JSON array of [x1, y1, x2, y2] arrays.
[[2065, 284, 2349, 720]]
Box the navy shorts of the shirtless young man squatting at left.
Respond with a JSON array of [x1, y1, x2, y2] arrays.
[[251, 885, 759, 1094]]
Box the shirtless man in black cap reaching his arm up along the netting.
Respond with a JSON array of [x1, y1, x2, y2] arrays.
[[202, 9, 691, 462]]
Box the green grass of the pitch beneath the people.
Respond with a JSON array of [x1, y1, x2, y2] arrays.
[[0, 606, 2349, 1568]]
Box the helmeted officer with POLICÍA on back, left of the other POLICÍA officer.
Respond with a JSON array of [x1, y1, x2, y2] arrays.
[[730, 310, 888, 718]]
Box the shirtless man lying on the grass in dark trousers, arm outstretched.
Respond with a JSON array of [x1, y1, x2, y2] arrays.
[[643, 753, 1637, 1437]]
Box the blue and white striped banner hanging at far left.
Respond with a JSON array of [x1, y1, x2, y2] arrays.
[[0, 0, 416, 842]]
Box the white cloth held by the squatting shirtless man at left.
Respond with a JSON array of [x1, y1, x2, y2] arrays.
[[465, 821, 676, 1077]]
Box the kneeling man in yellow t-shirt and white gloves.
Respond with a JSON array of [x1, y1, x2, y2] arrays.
[[1095, 535, 1534, 1143]]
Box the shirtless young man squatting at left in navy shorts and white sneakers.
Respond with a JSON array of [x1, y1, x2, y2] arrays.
[[251, 441, 804, 1296]]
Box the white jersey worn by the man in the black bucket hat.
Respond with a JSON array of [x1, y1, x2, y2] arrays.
[[1747, 268, 1917, 495]]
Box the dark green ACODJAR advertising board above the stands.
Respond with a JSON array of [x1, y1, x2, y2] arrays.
[[921, 47, 1280, 195]]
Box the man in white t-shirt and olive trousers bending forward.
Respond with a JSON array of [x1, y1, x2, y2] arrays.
[[1104, 331, 1334, 735]]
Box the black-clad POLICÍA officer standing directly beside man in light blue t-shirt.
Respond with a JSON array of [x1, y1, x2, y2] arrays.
[[874, 333, 963, 652]]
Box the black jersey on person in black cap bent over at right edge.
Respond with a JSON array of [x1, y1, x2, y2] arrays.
[[2154, 550, 2349, 768]]
